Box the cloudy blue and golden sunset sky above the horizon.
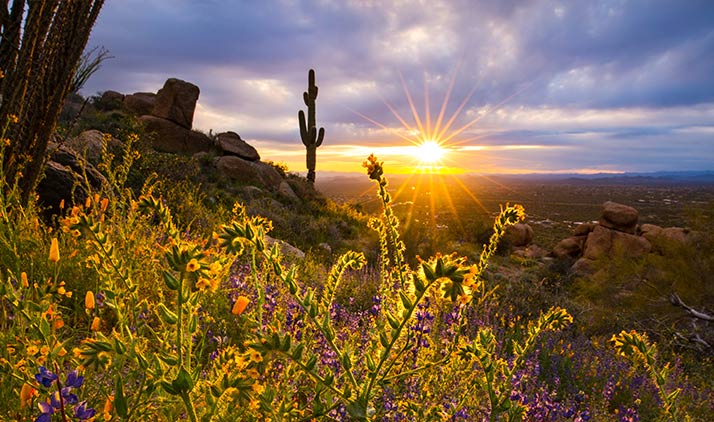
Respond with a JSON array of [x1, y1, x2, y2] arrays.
[[82, 0, 714, 177]]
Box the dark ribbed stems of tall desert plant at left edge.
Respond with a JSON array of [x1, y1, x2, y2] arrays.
[[0, 0, 104, 203]]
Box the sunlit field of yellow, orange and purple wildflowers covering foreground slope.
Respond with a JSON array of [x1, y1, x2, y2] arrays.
[[0, 117, 714, 421]]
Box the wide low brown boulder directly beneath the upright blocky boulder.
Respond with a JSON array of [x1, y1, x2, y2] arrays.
[[139, 116, 214, 154]]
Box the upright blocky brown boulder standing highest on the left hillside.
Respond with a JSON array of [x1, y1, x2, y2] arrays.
[[151, 78, 200, 129]]
